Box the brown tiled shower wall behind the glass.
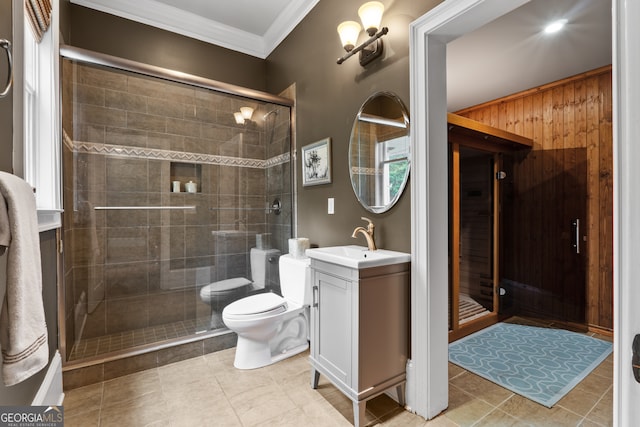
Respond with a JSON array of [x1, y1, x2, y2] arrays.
[[63, 60, 292, 362]]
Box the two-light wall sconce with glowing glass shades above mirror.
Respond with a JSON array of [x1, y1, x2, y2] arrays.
[[338, 1, 389, 67]]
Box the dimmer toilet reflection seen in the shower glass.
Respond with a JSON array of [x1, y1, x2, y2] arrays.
[[200, 248, 280, 329]]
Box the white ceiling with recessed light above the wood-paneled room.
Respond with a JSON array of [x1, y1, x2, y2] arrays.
[[447, 0, 611, 111]]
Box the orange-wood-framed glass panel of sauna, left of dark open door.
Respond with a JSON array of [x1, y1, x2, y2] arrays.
[[449, 144, 499, 338]]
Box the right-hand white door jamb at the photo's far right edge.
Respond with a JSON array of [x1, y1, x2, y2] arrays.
[[612, 0, 640, 426]]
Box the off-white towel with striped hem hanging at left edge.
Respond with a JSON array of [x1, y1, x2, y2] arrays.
[[0, 172, 49, 386]]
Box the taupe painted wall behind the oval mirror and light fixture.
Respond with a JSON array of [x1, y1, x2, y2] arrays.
[[267, 0, 446, 252]]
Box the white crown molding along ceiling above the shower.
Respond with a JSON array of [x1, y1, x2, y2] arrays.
[[71, 0, 319, 59]]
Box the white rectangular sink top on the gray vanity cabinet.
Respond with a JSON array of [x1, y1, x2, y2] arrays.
[[306, 245, 411, 269]]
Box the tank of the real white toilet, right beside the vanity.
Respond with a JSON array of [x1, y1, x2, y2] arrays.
[[280, 254, 311, 305]]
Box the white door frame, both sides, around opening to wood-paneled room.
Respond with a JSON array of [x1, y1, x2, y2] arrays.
[[407, 0, 640, 425]]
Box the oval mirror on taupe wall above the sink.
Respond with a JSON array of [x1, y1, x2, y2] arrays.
[[349, 92, 410, 213]]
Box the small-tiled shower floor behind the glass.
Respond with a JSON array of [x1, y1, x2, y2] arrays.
[[68, 319, 209, 360]]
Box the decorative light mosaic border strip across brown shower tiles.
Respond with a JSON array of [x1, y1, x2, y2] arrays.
[[64, 132, 290, 169]]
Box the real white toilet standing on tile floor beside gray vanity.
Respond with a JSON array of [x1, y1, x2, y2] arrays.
[[222, 254, 311, 369]]
